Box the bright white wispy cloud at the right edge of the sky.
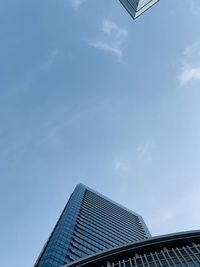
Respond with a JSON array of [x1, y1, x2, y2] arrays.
[[178, 40, 200, 86]]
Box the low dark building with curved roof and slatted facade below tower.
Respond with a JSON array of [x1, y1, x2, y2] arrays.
[[65, 231, 200, 267]]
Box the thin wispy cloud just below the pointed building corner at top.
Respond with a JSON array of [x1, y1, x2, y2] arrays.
[[89, 19, 128, 59]]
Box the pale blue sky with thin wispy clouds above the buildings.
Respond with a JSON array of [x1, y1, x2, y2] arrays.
[[0, 0, 200, 267]]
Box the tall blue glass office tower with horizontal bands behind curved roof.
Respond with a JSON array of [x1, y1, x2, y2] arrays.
[[35, 184, 151, 267]]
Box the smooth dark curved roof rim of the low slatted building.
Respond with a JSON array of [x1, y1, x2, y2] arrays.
[[65, 230, 200, 267]]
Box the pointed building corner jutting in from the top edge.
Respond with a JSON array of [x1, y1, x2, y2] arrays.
[[119, 0, 159, 19]]
